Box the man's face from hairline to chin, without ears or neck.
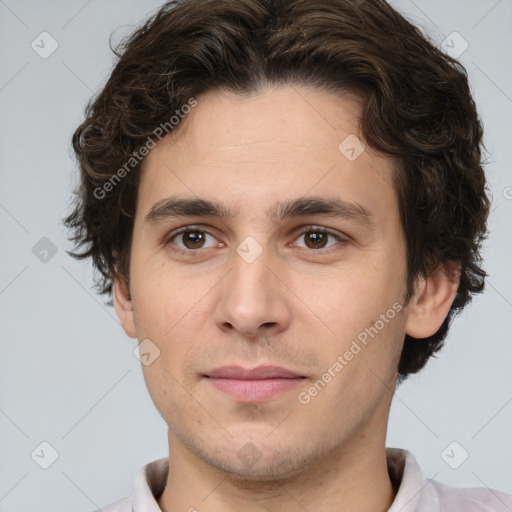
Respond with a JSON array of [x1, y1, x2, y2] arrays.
[[115, 86, 406, 479]]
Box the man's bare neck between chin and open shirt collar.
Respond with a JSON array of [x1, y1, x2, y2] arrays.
[[158, 430, 395, 512]]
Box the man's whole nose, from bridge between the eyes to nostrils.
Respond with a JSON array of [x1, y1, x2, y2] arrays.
[[216, 237, 290, 336]]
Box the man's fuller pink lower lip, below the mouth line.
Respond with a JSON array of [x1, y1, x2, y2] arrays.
[[207, 377, 304, 402]]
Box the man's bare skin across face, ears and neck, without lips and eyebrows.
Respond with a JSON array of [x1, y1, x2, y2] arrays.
[[114, 85, 457, 512]]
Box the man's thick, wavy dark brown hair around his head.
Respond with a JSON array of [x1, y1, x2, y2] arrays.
[[64, 0, 490, 378]]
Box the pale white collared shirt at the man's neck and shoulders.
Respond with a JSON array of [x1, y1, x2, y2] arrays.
[[94, 448, 512, 512]]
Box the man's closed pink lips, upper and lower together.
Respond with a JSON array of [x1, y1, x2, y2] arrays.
[[204, 366, 306, 403]]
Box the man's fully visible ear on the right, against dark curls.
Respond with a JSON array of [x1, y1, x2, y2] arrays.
[[405, 262, 460, 338]]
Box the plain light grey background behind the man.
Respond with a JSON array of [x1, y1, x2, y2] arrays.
[[0, 0, 512, 512]]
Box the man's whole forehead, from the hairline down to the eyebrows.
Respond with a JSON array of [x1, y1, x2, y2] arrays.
[[139, 86, 395, 225]]
